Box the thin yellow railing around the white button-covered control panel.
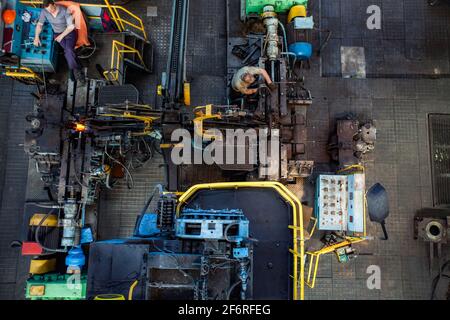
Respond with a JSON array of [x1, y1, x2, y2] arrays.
[[306, 165, 367, 288]]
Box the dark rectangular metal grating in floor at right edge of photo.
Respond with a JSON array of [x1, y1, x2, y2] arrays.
[[429, 114, 450, 206]]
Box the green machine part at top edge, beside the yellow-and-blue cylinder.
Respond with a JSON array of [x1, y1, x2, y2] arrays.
[[241, 0, 308, 21]]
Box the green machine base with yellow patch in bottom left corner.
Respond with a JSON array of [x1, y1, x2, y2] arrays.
[[25, 273, 87, 300]]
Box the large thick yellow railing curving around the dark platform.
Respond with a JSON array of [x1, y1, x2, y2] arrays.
[[176, 181, 305, 300]]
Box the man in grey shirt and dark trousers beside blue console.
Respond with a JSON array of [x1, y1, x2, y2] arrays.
[[33, 0, 86, 85]]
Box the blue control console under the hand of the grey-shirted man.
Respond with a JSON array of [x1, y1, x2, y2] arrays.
[[11, 2, 58, 72]]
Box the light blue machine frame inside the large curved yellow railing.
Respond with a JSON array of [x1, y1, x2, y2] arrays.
[[175, 209, 249, 243]]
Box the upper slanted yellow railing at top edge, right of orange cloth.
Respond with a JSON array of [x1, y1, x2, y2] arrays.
[[20, 0, 148, 41]]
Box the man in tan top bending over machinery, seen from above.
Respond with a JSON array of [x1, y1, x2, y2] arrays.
[[231, 67, 275, 95]]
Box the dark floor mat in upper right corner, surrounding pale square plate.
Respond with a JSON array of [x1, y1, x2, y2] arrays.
[[314, 0, 450, 78]]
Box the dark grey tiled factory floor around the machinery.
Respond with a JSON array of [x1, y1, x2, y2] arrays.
[[0, 0, 450, 299]]
